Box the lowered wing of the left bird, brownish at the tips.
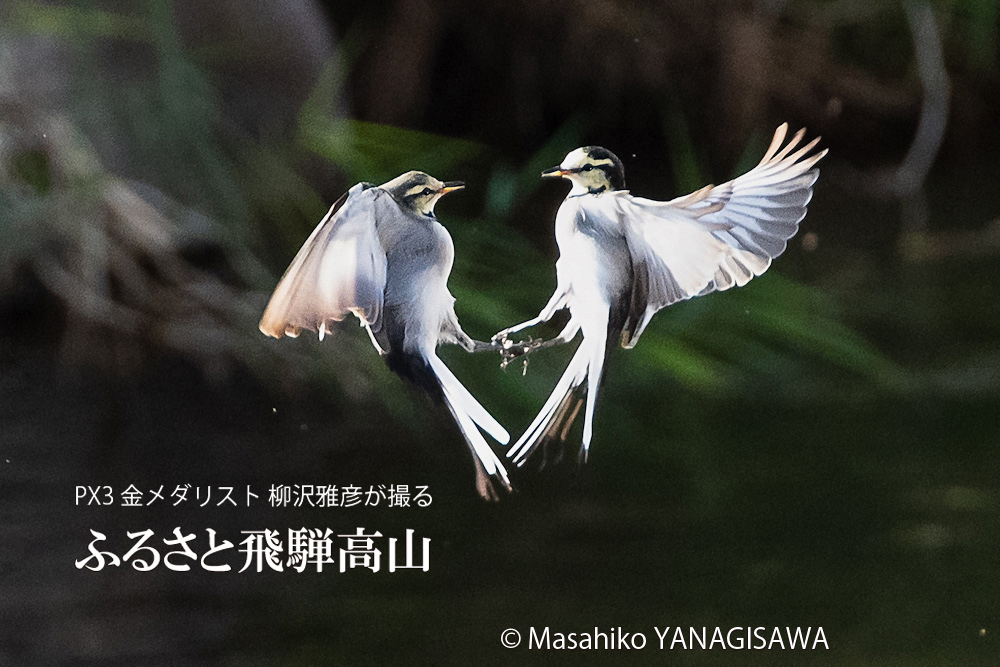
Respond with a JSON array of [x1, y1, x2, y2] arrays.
[[260, 183, 390, 338]]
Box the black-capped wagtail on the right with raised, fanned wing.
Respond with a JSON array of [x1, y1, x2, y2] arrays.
[[494, 124, 826, 466]]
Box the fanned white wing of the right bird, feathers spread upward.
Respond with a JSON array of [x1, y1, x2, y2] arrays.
[[619, 123, 826, 347]]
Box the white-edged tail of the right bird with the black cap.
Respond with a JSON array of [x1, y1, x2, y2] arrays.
[[507, 326, 607, 467]]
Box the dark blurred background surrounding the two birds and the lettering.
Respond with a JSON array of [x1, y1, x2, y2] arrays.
[[0, 0, 1000, 666]]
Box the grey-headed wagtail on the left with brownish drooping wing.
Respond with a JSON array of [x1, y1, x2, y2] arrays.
[[260, 171, 511, 499]]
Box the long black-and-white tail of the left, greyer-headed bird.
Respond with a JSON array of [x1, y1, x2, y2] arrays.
[[426, 351, 512, 500]]
